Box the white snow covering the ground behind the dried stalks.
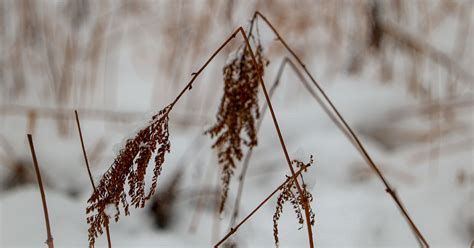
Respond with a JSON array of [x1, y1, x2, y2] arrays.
[[0, 0, 474, 247]]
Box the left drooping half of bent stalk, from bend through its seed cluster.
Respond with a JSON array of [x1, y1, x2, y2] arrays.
[[86, 29, 240, 245]]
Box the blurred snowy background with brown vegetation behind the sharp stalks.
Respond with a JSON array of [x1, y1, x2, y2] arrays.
[[0, 0, 474, 247]]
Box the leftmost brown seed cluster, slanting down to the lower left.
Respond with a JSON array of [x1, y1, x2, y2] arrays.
[[86, 105, 172, 247]]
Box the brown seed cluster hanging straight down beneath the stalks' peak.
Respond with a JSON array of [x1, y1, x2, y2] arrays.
[[205, 45, 268, 212]]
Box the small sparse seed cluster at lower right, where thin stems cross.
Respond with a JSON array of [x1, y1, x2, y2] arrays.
[[273, 156, 315, 247]]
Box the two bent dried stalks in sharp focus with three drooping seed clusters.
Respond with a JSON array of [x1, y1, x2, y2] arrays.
[[81, 12, 429, 247]]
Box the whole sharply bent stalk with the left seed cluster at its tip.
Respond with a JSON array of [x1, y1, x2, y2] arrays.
[[87, 23, 314, 248]]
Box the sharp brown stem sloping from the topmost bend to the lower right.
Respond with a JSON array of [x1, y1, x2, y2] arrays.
[[252, 11, 429, 247]]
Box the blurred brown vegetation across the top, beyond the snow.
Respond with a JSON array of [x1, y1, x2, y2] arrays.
[[0, 0, 474, 184]]
